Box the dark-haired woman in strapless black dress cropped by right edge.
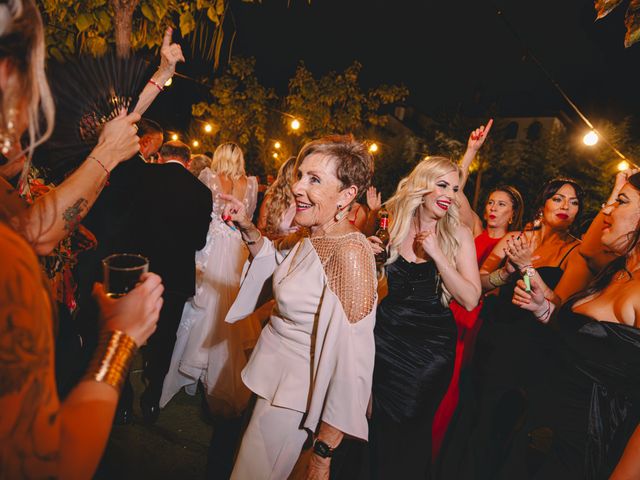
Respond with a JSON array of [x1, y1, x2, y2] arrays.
[[496, 172, 640, 480]]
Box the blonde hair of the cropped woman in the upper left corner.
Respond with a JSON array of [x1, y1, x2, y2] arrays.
[[0, 0, 55, 179]]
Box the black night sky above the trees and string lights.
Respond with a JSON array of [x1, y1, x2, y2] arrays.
[[154, 0, 640, 129]]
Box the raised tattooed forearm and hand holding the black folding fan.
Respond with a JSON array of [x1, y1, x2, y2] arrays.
[[21, 112, 140, 255]]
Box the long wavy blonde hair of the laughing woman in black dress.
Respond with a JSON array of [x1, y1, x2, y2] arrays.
[[386, 157, 462, 306]]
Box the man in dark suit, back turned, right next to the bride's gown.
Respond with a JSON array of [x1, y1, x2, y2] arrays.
[[127, 142, 212, 422]]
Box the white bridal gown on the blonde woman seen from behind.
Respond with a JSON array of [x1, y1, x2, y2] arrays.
[[160, 168, 260, 416]]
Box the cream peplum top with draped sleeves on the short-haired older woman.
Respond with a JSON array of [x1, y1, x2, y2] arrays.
[[226, 238, 376, 440]]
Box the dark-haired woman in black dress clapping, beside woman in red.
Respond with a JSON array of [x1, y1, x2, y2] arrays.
[[441, 178, 584, 478]]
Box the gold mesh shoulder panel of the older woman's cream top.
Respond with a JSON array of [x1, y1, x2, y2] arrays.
[[325, 235, 377, 323]]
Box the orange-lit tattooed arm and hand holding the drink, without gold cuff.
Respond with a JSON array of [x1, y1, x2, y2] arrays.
[[0, 223, 162, 479]]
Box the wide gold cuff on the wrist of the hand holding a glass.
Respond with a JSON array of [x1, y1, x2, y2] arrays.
[[84, 330, 138, 392]]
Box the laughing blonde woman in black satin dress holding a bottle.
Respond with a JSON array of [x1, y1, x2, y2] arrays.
[[370, 157, 481, 478]]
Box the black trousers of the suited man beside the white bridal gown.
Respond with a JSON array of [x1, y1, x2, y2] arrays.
[[142, 291, 188, 400]]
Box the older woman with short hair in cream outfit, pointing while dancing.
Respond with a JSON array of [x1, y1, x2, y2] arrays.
[[222, 136, 376, 480]]
